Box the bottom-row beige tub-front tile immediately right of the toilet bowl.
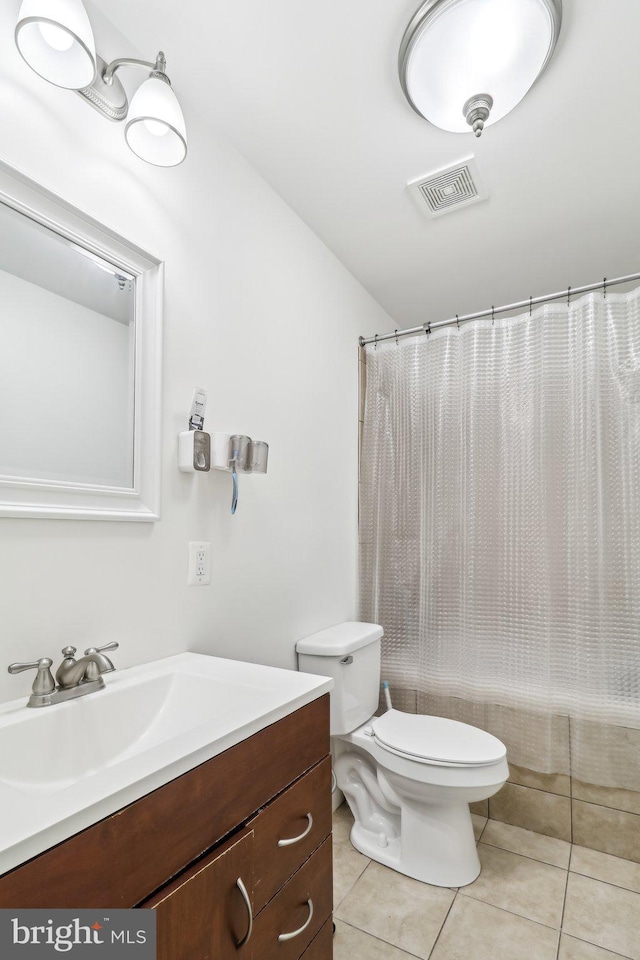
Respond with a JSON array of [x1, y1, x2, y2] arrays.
[[489, 783, 571, 840]]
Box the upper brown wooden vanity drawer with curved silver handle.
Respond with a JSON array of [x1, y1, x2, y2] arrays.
[[248, 757, 331, 913]]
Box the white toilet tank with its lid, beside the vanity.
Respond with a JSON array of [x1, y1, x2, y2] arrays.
[[296, 621, 384, 735]]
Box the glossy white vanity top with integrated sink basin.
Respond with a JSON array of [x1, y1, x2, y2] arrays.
[[0, 653, 332, 873]]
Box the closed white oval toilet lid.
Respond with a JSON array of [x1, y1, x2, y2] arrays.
[[372, 710, 507, 766]]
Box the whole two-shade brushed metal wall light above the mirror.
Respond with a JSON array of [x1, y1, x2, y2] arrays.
[[15, 0, 187, 167]]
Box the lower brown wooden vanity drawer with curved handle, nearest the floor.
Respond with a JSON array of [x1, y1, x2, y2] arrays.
[[254, 837, 333, 960]]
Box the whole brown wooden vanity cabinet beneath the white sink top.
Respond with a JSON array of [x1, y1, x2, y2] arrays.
[[0, 695, 332, 960]]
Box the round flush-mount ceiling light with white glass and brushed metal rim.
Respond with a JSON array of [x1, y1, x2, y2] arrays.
[[399, 0, 562, 137]]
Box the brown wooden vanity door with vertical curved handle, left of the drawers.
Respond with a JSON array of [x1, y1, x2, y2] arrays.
[[146, 830, 254, 960]]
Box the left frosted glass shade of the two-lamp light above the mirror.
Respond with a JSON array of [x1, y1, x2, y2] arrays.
[[15, 0, 96, 90]]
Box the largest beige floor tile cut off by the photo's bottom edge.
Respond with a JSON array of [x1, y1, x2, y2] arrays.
[[430, 895, 558, 960]]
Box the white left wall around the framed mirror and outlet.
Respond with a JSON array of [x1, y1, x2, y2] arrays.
[[0, 0, 393, 700]]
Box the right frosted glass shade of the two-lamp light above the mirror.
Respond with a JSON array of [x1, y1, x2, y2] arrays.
[[124, 76, 187, 167]]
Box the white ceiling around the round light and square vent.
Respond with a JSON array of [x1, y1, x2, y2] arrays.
[[93, 0, 640, 333]]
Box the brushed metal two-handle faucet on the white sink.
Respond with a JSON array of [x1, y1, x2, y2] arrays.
[[8, 640, 120, 707]]
